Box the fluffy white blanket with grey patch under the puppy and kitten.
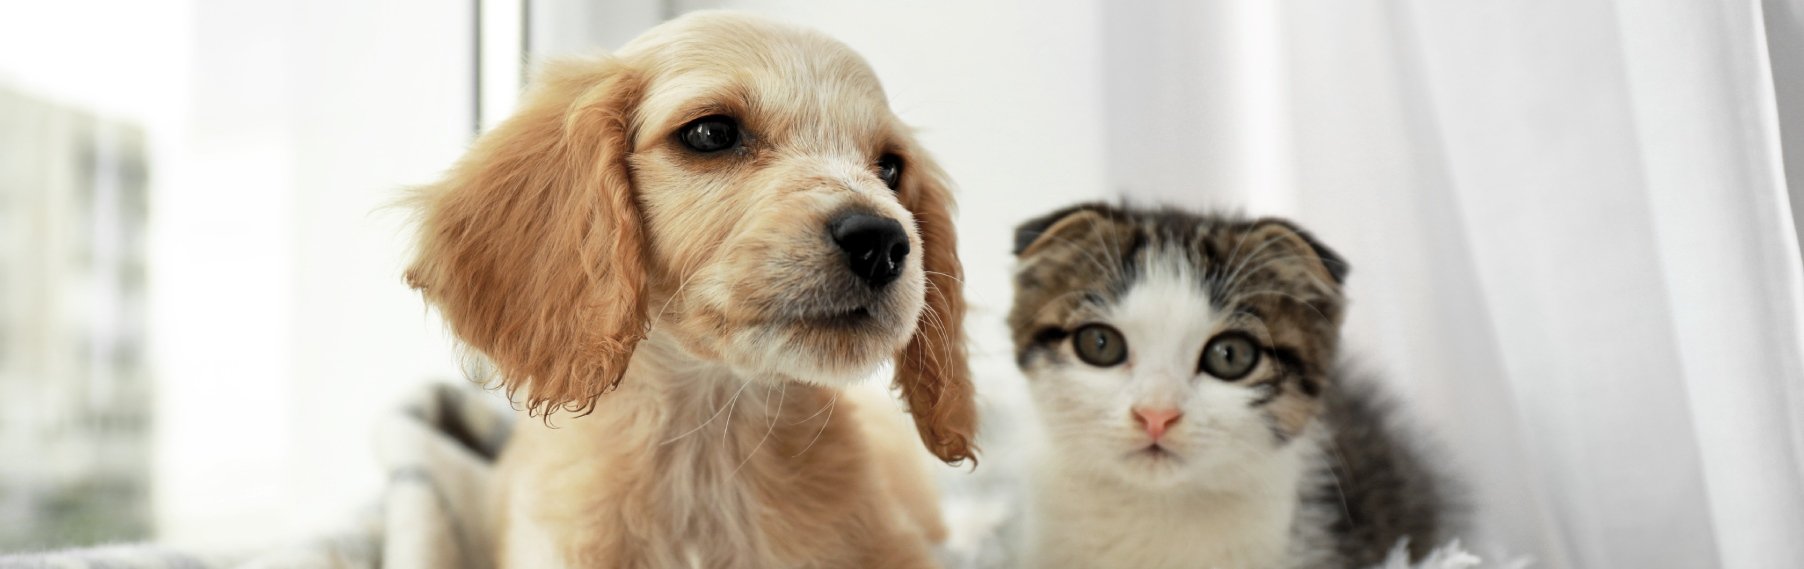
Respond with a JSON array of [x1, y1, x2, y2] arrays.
[[0, 385, 1526, 569]]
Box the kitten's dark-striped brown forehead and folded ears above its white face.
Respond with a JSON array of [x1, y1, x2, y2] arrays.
[[1008, 204, 1346, 437]]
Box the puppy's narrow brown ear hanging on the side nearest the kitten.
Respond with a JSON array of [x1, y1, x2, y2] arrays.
[[897, 145, 978, 464]]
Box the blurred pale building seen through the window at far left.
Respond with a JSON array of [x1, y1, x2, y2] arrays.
[[0, 85, 152, 551]]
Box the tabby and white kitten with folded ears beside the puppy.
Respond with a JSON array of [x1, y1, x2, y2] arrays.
[[1008, 204, 1449, 569]]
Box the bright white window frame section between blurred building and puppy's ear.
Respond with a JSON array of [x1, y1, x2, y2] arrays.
[[169, 0, 473, 546]]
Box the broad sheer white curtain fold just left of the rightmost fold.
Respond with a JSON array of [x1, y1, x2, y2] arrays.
[[1396, 2, 1717, 567]]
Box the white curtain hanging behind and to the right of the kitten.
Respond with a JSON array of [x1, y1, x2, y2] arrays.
[[1104, 0, 1804, 569]]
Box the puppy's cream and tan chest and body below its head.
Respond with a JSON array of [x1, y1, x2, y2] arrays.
[[502, 343, 916, 567]]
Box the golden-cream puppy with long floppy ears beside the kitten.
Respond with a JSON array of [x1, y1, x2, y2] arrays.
[[406, 13, 976, 567]]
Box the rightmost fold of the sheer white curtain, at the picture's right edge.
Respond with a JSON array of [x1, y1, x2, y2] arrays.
[[1618, 2, 1804, 567]]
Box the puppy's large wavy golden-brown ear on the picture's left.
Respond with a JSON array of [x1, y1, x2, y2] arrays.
[[408, 58, 646, 414]]
